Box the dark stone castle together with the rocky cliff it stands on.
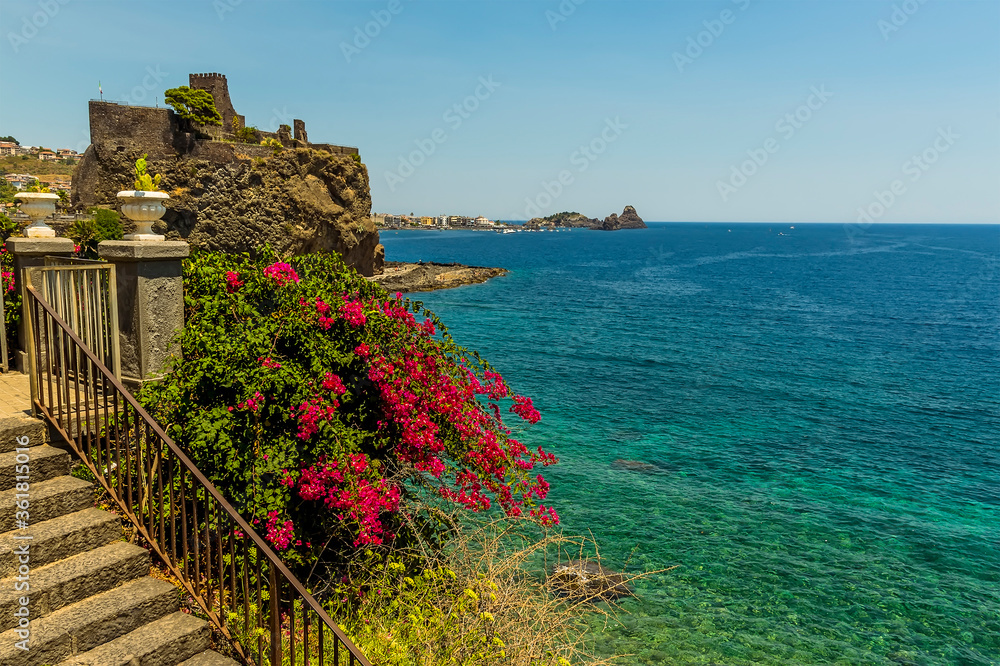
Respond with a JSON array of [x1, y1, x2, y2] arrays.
[[72, 74, 385, 276]]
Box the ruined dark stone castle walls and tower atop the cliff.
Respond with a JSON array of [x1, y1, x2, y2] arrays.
[[90, 73, 358, 161]]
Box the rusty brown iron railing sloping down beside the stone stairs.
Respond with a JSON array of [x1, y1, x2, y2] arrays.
[[23, 285, 371, 666]]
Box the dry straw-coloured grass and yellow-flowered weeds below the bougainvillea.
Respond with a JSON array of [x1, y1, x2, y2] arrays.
[[336, 519, 676, 666]]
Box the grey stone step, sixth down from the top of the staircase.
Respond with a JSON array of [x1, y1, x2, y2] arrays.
[[0, 576, 181, 666]]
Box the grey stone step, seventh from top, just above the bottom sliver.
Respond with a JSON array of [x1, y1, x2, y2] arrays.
[[59, 612, 211, 666]]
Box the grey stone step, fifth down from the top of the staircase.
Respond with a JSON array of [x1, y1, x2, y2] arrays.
[[0, 541, 149, 631]]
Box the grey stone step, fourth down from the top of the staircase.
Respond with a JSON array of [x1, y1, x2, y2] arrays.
[[0, 509, 122, 572]]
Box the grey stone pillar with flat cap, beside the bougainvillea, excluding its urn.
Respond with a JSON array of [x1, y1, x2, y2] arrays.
[[97, 241, 190, 391]]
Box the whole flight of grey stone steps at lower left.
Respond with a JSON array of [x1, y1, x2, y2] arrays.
[[0, 414, 237, 666]]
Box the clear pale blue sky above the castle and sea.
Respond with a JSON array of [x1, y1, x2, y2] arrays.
[[0, 0, 1000, 223]]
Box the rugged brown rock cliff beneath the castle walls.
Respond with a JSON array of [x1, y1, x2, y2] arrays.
[[73, 142, 384, 276]]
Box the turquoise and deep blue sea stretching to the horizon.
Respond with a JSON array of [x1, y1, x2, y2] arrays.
[[382, 224, 1000, 665]]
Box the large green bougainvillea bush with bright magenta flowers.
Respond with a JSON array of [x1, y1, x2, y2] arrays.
[[142, 250, 558, 576]]
